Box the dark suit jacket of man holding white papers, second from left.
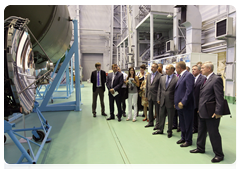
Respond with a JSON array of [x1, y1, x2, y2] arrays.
[[106, 72, 123, 93]]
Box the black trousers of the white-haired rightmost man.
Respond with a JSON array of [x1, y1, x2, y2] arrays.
[[197, 118, 224, 157]]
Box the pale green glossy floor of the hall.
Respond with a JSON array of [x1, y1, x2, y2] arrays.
[[4, 82, 238, 169]]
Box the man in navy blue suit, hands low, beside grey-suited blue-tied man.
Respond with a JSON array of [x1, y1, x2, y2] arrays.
[[174, 61, 194, 147]]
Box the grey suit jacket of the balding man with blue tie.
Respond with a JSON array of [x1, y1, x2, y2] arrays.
[[157, 74, 178, 108]]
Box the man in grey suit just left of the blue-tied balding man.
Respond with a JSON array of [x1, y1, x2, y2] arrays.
[[145, 63, 162, 127]]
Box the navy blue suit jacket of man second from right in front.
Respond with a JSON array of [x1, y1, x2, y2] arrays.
[[174, 71, 194, 110]]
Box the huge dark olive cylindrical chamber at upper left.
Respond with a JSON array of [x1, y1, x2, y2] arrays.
[[4, 5, 72, 69]]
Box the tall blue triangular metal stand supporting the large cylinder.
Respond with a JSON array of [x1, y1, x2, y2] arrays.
[[39, 20, 81, 111]]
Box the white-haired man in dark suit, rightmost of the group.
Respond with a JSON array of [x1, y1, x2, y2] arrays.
[[190, 62, 224, 163]]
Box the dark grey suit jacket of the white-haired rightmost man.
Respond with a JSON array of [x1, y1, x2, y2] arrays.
[[199, 73, 224, 119]]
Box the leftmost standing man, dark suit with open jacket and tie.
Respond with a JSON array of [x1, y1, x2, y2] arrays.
[[91, 63, 107, 117]]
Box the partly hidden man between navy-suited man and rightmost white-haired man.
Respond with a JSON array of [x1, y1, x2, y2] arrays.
[[192, 65, 205, 133]]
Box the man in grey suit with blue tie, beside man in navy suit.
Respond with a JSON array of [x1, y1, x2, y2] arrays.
[[153, 65, 178, 138]]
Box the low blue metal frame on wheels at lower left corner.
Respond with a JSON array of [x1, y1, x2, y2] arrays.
[[4, 102, 52, 169]]
